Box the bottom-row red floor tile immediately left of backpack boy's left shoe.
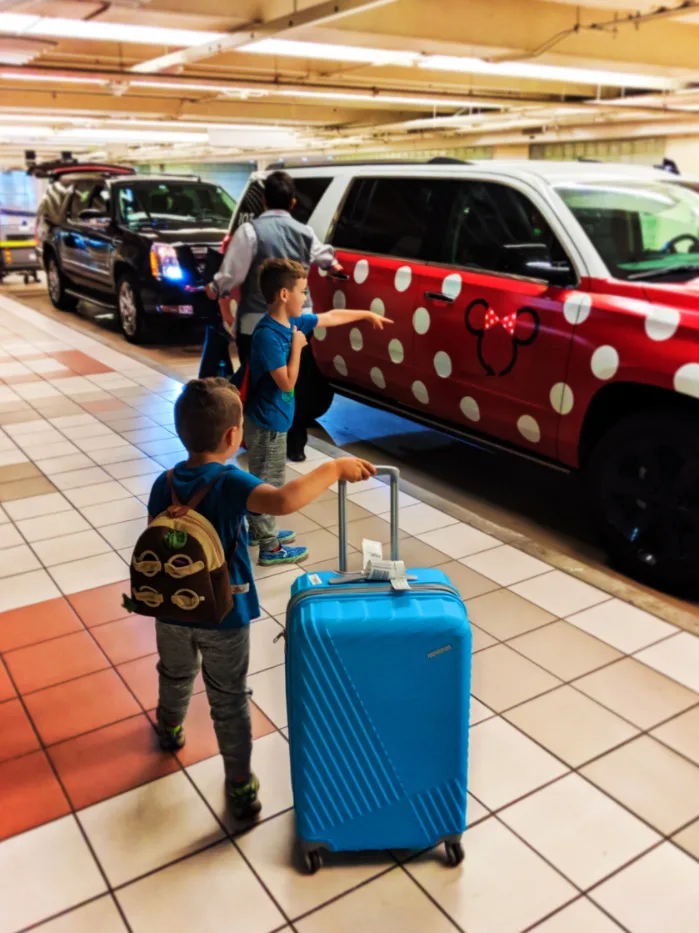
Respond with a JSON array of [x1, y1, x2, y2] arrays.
[[49, 714, 179, 810]]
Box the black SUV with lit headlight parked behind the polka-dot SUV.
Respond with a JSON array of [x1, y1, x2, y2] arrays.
[[30, 162, 235, 343]]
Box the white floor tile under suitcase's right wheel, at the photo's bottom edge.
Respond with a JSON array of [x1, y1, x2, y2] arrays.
[[406, 819, 577, 933]]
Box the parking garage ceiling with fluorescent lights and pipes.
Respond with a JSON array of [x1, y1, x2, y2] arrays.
[[0, 0, 699, 168]]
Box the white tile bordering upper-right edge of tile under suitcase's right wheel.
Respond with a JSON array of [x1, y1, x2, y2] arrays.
[[500, 774, 660, 889]]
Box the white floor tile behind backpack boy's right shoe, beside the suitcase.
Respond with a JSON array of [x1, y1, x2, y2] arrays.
[[187, 732, 294, 829]]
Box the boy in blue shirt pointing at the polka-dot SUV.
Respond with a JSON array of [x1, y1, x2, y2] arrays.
[[245, 259, 393, 567]]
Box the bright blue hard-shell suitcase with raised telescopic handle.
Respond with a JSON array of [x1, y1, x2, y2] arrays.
[[286, 467, 471, 873]]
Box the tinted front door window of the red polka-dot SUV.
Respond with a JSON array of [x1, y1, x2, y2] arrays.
[[443, 181, 568, 272]]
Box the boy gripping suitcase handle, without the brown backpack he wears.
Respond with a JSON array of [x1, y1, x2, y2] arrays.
[[148, 378, 375, 820]]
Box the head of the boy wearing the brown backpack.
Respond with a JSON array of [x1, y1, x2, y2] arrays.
[[175, 378, 243, 454]]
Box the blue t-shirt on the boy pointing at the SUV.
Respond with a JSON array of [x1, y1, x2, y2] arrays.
[[245, 314, 318, 434]]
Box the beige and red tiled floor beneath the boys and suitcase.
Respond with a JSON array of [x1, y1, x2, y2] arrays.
[[0, 297, 699, 933]]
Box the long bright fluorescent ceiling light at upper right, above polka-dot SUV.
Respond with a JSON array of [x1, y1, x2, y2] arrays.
[[419, 55, 678, 90]]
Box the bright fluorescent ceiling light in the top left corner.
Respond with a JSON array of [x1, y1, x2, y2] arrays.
[[0, 13, 227, 47]]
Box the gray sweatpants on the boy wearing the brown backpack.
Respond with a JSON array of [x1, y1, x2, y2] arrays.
[[155, 621, 252, 785]]
